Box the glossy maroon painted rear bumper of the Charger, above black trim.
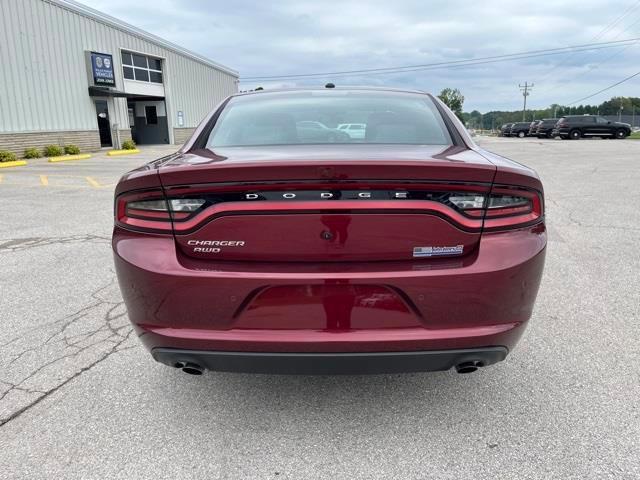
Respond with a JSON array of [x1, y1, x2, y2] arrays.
[[113, 224, 546, 358]]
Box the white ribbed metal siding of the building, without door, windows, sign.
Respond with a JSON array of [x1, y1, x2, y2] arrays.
[[0, 0, 237, 139]]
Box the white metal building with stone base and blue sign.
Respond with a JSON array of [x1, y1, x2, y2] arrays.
[[0, 0, 238, 156]]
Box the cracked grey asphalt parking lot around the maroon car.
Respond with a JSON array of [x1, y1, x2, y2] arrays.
[[0, 138, 640, 479]]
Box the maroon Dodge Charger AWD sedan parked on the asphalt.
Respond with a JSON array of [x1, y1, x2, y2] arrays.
[[113, 88, 546, 374]]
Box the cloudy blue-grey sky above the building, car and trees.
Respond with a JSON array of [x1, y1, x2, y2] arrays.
[[82, 0, 640, 112]]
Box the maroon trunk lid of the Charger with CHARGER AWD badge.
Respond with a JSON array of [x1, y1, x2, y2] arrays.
[[159, 145, 496, 262]]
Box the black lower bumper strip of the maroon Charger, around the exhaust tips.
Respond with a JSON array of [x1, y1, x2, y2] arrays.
[[151, 347, 508, 375]]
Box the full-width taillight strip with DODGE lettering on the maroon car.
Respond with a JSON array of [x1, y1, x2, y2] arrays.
[[115, 184, 544, 234]]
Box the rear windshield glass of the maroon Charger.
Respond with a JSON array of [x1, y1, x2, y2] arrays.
[[207, 91, 452, 148]]
